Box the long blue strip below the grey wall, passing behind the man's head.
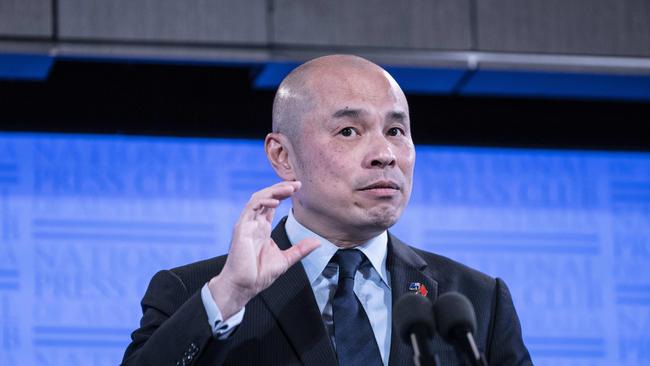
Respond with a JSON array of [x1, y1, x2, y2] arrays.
[[253, 62, 650, 101]]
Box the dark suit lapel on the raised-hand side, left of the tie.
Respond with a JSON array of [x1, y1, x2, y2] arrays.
[[260, 218, 337, 365]]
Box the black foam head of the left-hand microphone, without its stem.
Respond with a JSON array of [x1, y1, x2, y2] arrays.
[[393, 293, 436, 344]]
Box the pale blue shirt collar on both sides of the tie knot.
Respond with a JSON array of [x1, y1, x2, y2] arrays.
[[284, 210, 389, 286]]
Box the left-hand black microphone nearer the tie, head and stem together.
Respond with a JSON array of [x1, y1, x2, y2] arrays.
[[393, 293, 440, 366]]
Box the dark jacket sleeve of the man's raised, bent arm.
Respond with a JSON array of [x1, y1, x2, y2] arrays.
[[122, 270, 212, 366]]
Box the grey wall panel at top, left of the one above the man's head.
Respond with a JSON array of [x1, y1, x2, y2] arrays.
[[59, 0, 266, 43]]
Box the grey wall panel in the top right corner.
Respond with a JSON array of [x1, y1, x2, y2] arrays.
[[476, 0, 650, 56]]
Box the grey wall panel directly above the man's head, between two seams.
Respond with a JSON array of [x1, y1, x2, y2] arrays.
[[272, 0, 471, 49]]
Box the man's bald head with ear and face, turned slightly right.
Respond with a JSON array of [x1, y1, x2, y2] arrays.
[[266, 55, 415, 246]]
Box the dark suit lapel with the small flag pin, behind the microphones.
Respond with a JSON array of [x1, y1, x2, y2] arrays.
[[387, 233, 438, 366]]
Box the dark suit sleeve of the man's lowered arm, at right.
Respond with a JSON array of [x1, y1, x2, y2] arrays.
[[485, 278, 533, 366]]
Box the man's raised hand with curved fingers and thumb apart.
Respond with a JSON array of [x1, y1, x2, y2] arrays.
[[208, 182, 320, 319]]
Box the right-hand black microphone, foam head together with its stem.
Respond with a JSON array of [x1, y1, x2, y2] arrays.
[[433, 292, 487, 366]]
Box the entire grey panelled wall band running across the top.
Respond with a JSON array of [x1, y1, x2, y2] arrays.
[[0, 0, 650, 61]]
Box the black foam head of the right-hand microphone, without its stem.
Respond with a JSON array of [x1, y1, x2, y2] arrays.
[[433, 292, 476, 343]]
